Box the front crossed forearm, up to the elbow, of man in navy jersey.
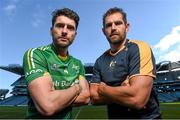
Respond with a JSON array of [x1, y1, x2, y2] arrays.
[[98, 82, 151, 109]]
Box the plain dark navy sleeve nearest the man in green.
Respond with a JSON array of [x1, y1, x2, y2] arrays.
[[91, 59, 101, 83]]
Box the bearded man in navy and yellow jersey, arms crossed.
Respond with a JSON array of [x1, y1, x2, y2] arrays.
[[90, 7, 161, 119]]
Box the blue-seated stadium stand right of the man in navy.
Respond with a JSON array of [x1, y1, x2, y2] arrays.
[[154, 61, 180, 102]]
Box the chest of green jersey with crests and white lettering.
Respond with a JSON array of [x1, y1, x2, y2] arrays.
[[46, 53, 80, 89]]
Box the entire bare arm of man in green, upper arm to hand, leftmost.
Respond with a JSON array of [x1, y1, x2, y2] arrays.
[[28, 75, 80, 116]]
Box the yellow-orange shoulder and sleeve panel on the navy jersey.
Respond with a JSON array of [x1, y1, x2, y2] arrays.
[[130, 40, 154, 76]]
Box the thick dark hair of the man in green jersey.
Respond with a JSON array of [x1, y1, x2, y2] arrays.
[[52, 8, 80, 29]]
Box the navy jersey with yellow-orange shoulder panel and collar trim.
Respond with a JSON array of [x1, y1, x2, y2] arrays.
[[92, 40, 160, 119]]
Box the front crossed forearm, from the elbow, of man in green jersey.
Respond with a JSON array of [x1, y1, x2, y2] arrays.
[[32, 85, 80, 116]]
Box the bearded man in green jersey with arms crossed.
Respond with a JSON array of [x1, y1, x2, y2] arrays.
[[23, 8, 90, 119]]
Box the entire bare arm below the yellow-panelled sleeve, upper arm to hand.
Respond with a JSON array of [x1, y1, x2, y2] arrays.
[[98, 76, 153, 109]]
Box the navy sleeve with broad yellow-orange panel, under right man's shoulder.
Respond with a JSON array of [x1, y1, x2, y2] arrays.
[[129, 41, 156, 78]]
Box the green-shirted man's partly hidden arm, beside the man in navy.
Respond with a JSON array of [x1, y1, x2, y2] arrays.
[[73, 79, 90, 106]]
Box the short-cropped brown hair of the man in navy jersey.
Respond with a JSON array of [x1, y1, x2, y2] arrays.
[[103, 7, 127, 26]]
